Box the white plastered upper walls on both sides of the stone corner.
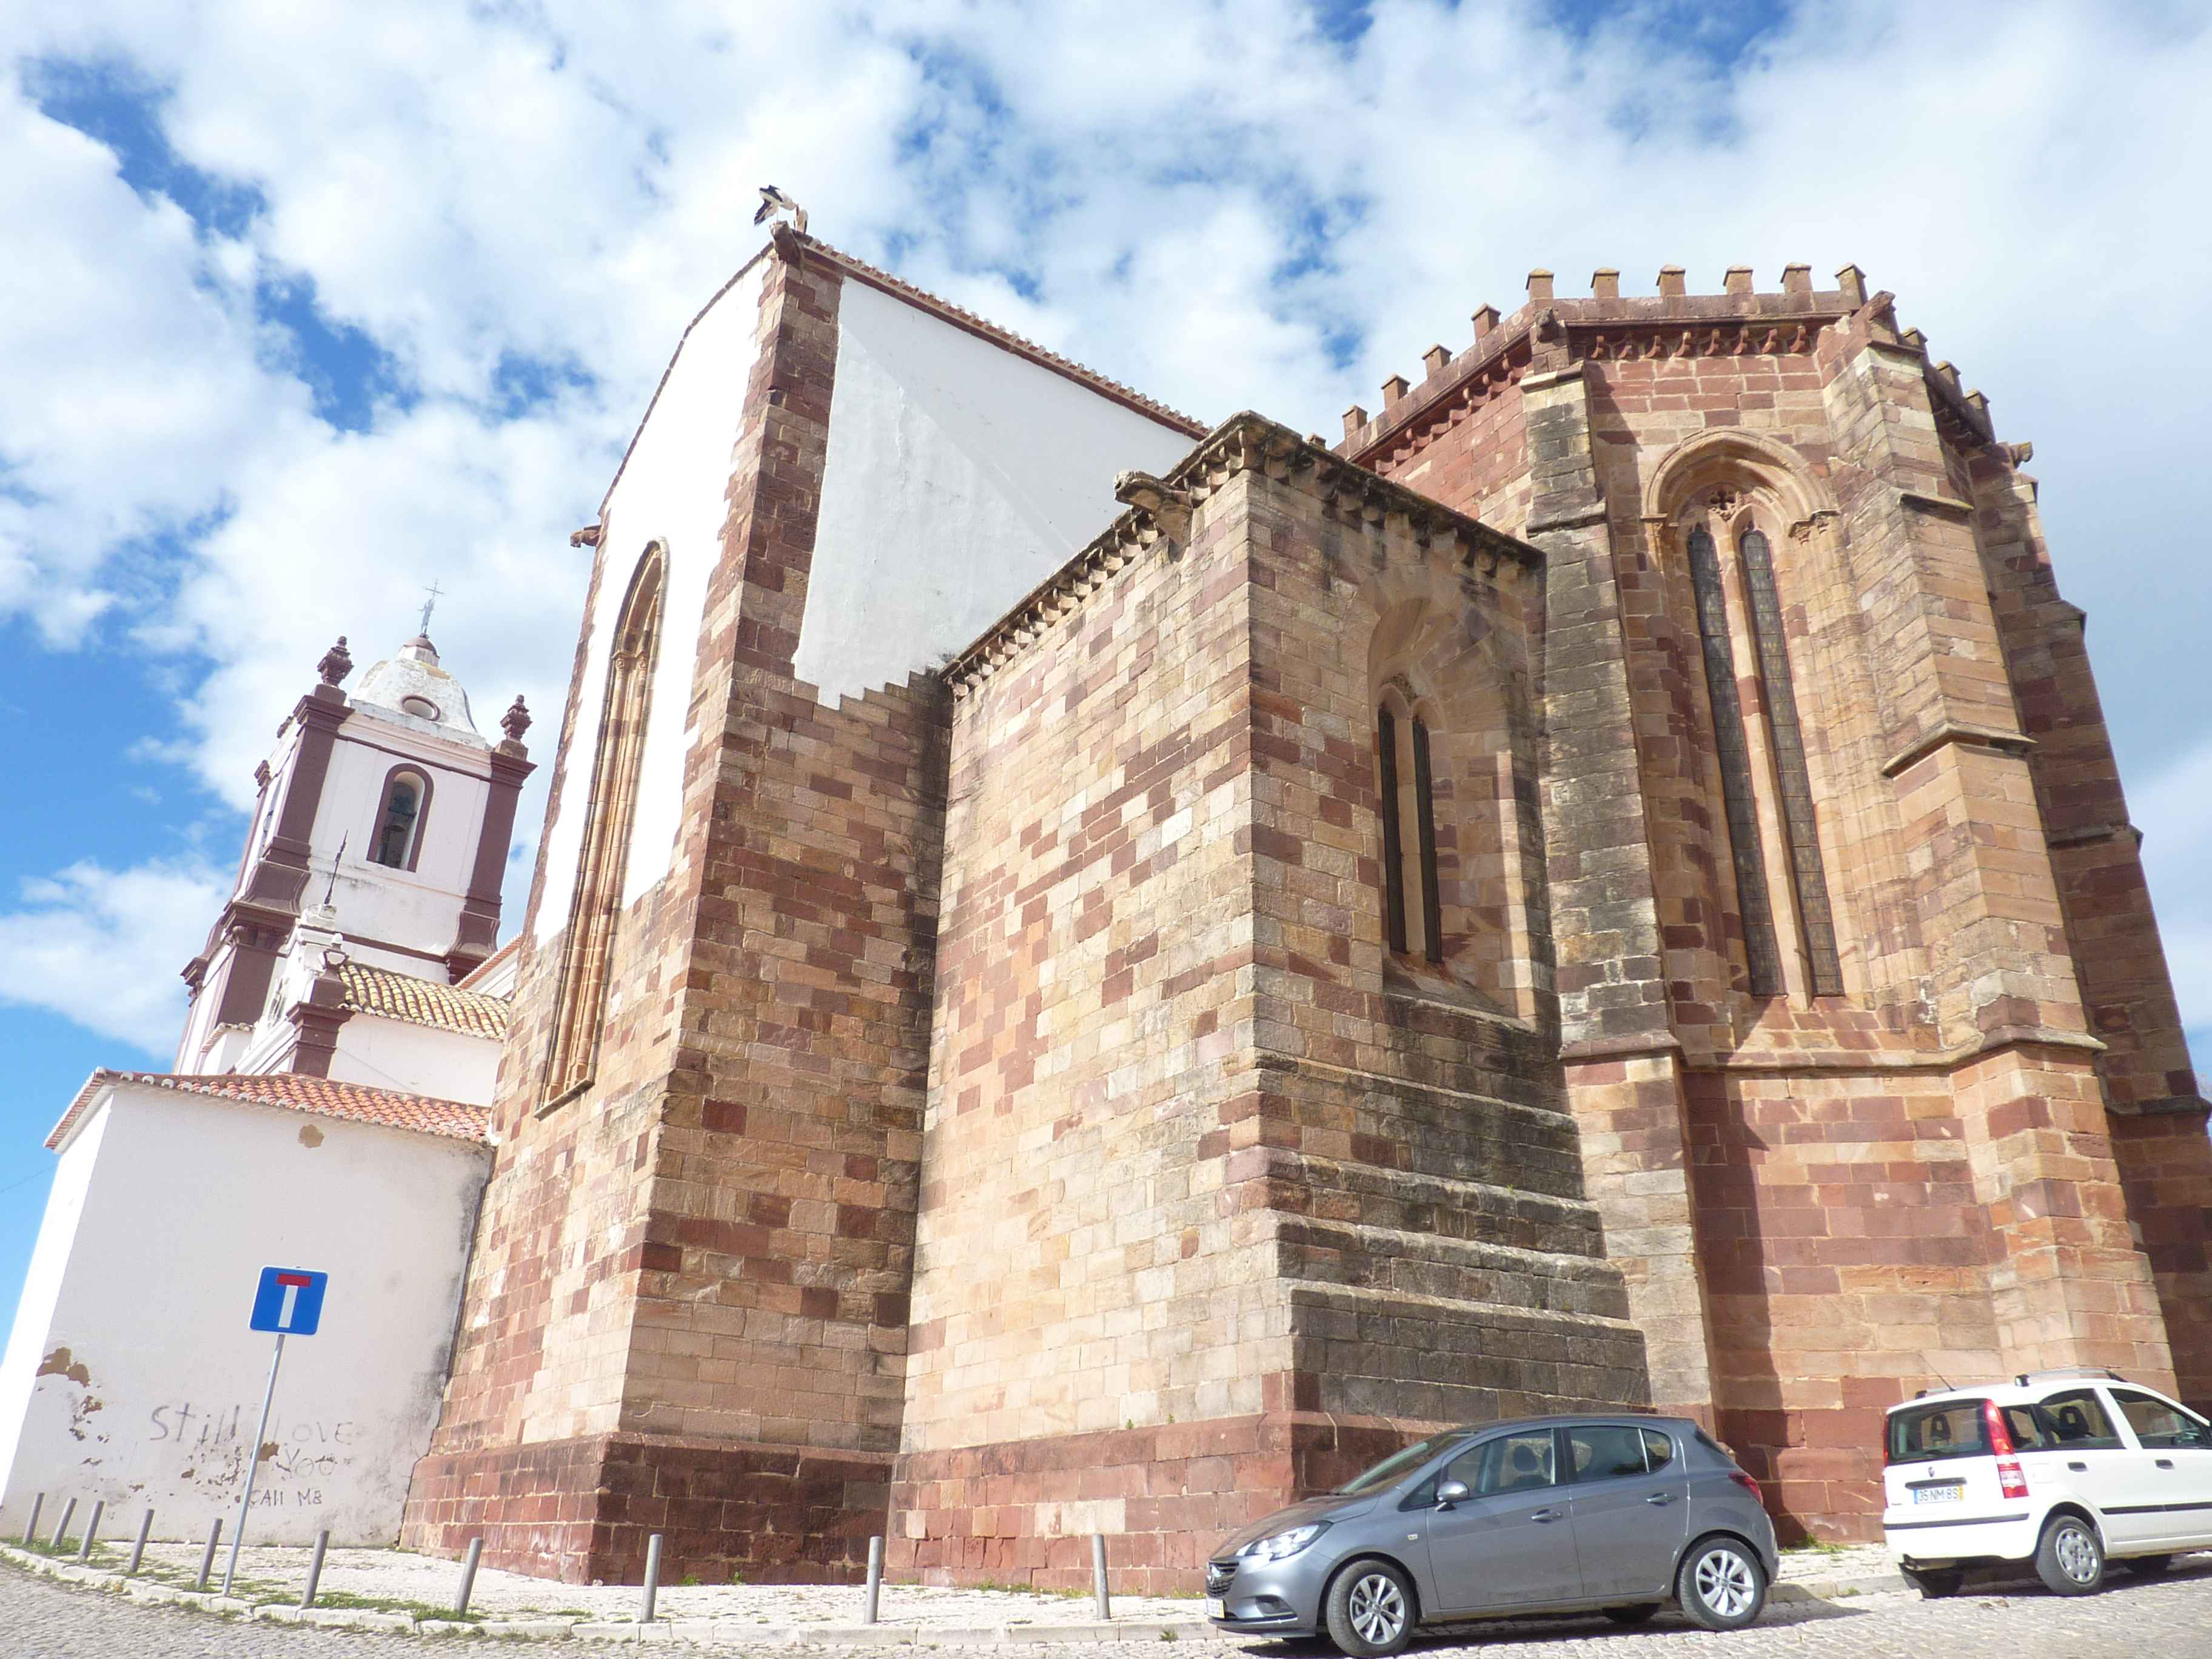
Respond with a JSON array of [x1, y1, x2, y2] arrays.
[[531, 252, 1195, 947]]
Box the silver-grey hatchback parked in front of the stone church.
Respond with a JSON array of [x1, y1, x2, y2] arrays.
[[1205, 1413, 1776, 1659]]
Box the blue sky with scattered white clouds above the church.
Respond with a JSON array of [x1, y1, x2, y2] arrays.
[[0, 0, 2212, 1336]]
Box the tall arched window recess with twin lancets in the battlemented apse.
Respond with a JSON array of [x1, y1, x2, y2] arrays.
[[1643, 429, 1845, 997]]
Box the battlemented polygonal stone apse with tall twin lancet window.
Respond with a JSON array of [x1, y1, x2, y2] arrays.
[[1341, 267, 2212, 1537]]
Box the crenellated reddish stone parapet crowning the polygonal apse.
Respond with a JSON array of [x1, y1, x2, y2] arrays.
[[1336, 266, 2026, 464]]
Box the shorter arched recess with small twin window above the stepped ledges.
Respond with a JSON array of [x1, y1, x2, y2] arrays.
[[1367, 584, 1549, 1017]]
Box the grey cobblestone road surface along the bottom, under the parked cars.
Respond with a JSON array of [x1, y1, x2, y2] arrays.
[[13, 1564, 2212, 1659]]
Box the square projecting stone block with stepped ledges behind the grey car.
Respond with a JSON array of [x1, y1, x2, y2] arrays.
[[891, 416, 1646, 1588]]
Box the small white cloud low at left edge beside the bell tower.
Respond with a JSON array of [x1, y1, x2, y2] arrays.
[[0, 863, 228, 1059]]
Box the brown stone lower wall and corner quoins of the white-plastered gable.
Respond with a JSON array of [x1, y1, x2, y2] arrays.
[[405, 234, 942, 1580]]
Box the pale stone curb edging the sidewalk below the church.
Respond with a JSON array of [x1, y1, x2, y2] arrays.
[[0, 1544, 1909, 1648]]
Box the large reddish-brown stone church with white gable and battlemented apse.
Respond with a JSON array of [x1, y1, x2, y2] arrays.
[[389, 228, 2212, 1588]]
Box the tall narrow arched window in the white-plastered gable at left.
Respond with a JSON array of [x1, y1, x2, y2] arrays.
[[540, 542, 668, 1110]]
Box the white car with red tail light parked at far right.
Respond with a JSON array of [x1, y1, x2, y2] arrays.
[[1882, 1369, 2212, 1595]]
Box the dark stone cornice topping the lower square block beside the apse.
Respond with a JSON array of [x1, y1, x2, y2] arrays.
[[942, 409, 1544, 697]]
